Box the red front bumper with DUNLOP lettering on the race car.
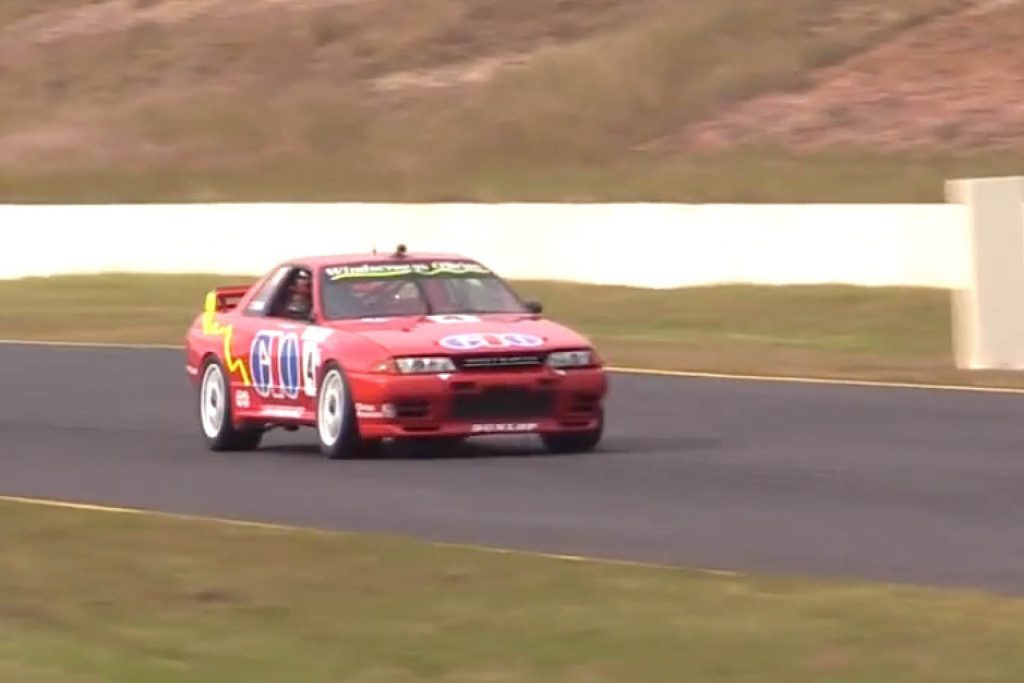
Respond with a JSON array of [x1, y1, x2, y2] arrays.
[[349, 368, 607, 438]]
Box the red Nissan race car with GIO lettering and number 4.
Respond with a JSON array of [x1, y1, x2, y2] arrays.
[[185, 246, 607, 459]]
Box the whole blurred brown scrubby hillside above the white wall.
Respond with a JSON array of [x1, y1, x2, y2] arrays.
[[0, 0, 1024, 201]]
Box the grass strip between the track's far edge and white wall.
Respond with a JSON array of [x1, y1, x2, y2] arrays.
[[6, 274, 1024, 386]]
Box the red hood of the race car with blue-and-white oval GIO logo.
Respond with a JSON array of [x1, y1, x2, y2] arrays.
[[319, 314, 590, 355]]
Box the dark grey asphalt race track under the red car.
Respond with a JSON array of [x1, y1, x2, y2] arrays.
[[0, 345, 1024, 592]]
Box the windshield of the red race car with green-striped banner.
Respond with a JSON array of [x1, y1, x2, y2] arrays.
[[321, 261, 526, 321]]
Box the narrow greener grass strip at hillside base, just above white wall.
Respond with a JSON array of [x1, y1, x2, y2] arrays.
[[6, 150, 1024, 204]]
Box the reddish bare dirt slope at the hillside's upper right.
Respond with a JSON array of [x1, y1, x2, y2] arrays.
[[676, 0, 1024, 152]]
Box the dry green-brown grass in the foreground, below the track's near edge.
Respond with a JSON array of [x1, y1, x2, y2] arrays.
[[6, 502, 1024, 683]]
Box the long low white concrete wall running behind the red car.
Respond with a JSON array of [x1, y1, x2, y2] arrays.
[[0, 204, 970, 289]]
